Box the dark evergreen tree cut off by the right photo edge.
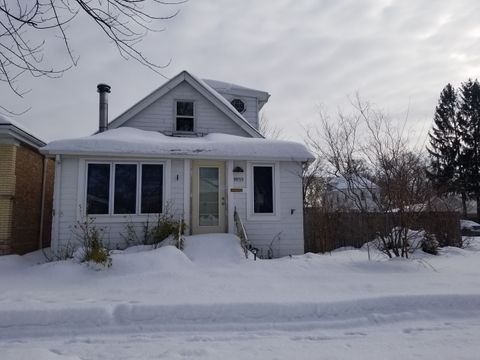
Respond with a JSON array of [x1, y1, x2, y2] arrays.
[[458, 79, 480, 216]]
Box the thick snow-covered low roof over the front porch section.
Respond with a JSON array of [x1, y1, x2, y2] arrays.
[[41, 127, 313, 161]]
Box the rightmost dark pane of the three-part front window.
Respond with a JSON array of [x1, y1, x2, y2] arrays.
[[141, 165, 163, 214]]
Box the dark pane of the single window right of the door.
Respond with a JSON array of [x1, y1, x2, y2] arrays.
[[253, 166, 273, 214]]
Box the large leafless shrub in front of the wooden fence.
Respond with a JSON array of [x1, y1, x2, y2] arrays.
[[307, 96, 454, 257]]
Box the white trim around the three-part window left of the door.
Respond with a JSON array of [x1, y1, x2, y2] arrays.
[[77, 159, 167, 222]]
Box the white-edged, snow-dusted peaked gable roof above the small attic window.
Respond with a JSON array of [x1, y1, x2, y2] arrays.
[[108, 70, 263, 138]]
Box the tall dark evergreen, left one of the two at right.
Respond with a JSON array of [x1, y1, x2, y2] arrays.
[[427, 84, 460, 194]]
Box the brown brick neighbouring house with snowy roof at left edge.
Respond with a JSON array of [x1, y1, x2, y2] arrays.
[[0, 115, 55, 255]]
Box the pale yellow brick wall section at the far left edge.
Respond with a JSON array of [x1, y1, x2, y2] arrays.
[[0, 144, 17, 255]]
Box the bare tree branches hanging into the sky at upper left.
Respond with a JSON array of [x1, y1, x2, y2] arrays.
[[0, 0, 186, 100]]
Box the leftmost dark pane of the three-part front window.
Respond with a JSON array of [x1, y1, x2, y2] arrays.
[[87, 164, 110, 214]]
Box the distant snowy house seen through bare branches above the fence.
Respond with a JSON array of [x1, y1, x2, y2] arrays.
[[326, 176, 380, 212]]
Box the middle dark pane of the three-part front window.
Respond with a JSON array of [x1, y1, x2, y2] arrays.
[[113, 164, 137, 214]]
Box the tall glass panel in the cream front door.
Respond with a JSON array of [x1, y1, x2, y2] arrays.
[[198, 167, 219, 226]]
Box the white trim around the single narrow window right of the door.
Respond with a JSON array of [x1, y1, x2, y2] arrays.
[[247, 161, 281, 221]]
